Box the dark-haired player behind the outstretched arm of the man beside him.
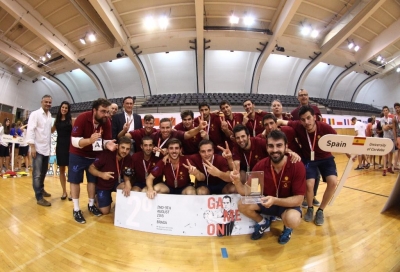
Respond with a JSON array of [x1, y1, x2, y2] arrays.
[[174, 110, 207, 155]]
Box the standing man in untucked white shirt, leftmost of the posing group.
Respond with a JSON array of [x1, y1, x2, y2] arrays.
[[26, 94, 53, 206]]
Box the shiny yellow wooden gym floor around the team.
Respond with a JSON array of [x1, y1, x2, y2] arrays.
[[0, 155, 400, 272]]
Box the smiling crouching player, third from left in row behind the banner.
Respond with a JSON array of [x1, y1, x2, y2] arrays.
[[146, 138, 200, 199]]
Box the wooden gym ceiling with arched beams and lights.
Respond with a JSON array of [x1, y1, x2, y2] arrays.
[[0, 0, 400, 102]]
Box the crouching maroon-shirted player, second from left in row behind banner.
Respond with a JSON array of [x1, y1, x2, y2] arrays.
[[132, 136, 162, 192]]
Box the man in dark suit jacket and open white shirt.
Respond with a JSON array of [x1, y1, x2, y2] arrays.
[[112, 96, 143, 139]]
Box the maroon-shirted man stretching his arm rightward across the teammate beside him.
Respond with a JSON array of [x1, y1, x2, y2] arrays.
[[151, 118, 207, 157]]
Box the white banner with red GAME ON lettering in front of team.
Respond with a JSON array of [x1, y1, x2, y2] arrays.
[[114, 190, 255, 236]]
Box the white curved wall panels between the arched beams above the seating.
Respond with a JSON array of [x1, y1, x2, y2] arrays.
[[0, 50, 400, 109]]
